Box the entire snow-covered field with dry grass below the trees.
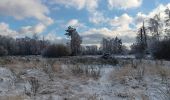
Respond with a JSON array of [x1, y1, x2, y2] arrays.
[[0, 57, 170, 100]]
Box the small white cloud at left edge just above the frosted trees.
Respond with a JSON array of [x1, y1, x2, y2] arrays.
[[0, 22, 18, 36]]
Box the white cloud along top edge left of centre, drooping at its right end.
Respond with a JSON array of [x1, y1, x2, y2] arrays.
[[52, 0, 99, 24]]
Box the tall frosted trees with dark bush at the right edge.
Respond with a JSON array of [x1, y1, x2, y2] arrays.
[[131, 8, 170, 60]]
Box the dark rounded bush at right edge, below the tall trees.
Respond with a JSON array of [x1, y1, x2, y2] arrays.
[[152, 39, 170, 60]]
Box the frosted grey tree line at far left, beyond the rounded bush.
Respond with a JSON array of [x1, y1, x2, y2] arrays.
[[0, 36, 49, 56]]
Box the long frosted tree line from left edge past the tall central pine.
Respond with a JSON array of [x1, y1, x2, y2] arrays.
[[0, 26, 122, 57]]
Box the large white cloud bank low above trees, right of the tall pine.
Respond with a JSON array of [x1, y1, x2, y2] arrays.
[[80, 13, 136, 44]]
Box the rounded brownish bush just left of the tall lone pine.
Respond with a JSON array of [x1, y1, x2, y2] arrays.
[[42, 44, 70, 58]]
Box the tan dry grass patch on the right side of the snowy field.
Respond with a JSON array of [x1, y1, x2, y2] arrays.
[[110, 61, 170, 82]]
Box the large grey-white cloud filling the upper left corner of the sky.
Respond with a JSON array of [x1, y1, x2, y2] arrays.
[[0, 0, 53, 35]]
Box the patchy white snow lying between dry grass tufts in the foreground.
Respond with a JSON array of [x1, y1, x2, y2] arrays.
[[0, 57, 170, 100]]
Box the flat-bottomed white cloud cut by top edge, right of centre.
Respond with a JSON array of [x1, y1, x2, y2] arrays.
[[108, 0, 142, 9]]
